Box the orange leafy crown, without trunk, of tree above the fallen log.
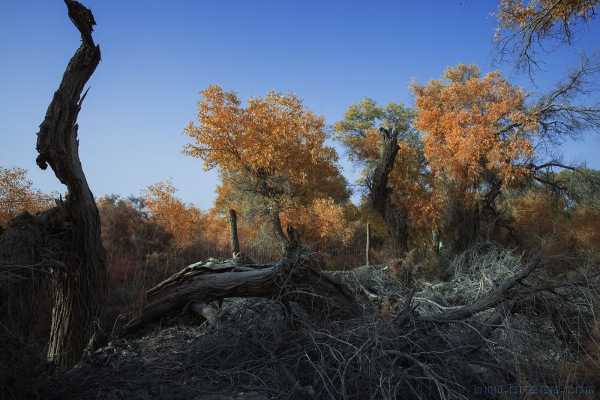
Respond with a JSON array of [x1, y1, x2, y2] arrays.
[[182, 85, 337, 203]]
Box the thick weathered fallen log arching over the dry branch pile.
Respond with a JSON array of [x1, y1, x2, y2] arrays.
[[120, 245, 359, 336]]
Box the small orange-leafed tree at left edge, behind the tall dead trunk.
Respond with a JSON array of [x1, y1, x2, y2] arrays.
[[0, 166, 54, 226]]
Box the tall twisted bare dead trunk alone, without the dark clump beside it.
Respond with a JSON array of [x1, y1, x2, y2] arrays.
[[36, 0, 108, 370]]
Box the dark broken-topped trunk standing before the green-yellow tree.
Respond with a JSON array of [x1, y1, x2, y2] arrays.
[[368, 128, 408, 256]]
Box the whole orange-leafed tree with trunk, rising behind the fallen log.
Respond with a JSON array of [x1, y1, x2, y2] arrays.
[[182, 86, 343, 252]]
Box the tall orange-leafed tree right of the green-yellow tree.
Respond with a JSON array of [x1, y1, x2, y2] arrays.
[[410, 64, 538, 245]]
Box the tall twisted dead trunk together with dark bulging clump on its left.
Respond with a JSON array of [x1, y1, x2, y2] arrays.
[[0, 0, 108, 369]]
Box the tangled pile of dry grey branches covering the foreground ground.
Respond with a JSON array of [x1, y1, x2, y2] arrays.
[[16, 245, 600, 399]]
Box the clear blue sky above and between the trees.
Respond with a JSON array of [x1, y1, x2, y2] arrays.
[[0, 0, 600, 209]]
